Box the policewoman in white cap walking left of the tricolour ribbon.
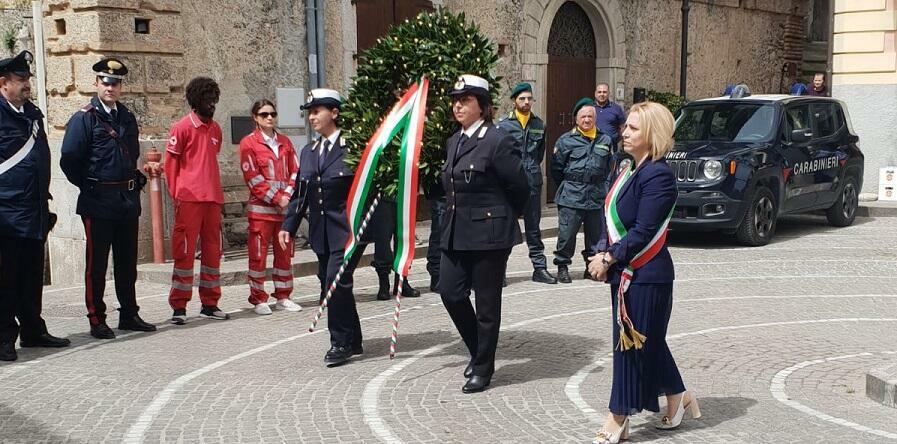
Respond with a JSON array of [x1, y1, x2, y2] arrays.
[[278, 88, 364, 367]]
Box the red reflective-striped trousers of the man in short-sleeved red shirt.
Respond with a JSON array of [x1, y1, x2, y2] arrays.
[[168, 202, 221, 310]]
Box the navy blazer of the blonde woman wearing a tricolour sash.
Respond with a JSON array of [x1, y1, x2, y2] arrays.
[[592, 160, 679, 284]]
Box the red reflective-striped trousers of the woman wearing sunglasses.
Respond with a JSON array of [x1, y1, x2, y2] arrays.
[[246, 218, 293, 305]]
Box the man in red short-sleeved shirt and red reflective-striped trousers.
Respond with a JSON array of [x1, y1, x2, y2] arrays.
[[165, 77, 230, 325]]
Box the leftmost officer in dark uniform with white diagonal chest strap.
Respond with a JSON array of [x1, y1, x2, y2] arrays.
[[0, 51, 70, 361]]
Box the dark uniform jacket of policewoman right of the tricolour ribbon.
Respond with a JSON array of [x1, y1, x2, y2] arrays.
[[442, 122, 529, 251]]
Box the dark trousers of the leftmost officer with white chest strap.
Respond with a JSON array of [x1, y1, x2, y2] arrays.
[[0, 237, 47, 342]]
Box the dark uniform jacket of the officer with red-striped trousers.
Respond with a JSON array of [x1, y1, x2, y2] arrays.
[[59, 97, 140, 219]]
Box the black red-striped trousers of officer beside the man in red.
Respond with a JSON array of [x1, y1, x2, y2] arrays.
[[81, 216, 140, 325]]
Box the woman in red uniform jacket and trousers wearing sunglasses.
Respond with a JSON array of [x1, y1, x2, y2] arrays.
[[240, 99, 302, 315]]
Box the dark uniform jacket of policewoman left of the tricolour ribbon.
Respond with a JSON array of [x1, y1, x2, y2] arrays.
[[282, 137, 355, 254]]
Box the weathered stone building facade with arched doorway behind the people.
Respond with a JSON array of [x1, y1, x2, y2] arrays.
[[22, 0, 812, 283]]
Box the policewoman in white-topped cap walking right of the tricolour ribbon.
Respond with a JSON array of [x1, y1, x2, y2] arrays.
[[438, 74, 529, 393]]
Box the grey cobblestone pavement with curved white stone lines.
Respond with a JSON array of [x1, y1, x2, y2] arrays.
[[0, 217, 897, 443]]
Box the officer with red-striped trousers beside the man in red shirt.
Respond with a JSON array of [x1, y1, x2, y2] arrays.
[[59, 58, 156, 339]]
